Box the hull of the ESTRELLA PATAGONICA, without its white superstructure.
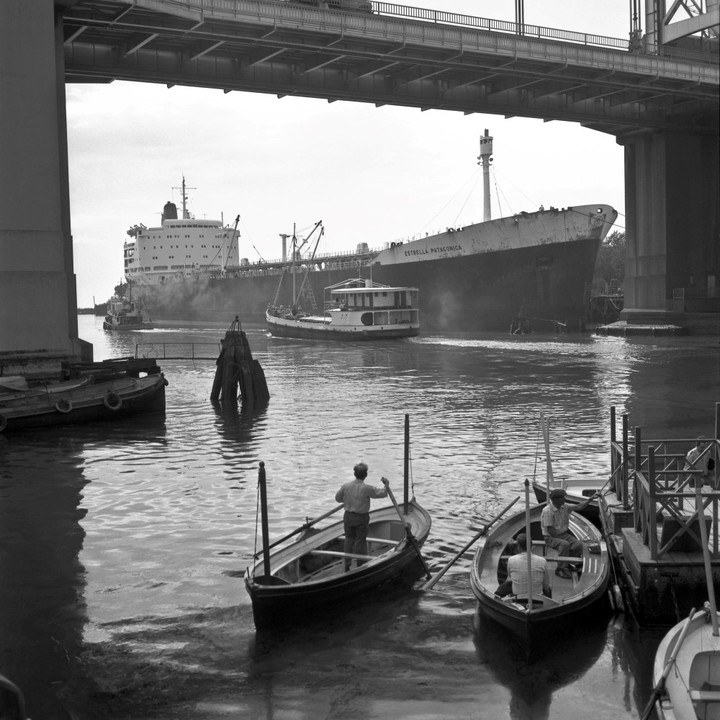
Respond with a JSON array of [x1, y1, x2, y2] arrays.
[[133, 206, 617, 332]]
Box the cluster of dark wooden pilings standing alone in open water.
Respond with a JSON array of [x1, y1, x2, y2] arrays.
[[210, 316, 270, 406]]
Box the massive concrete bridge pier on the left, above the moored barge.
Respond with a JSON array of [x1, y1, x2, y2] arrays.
[[0, 0, 92, 374]]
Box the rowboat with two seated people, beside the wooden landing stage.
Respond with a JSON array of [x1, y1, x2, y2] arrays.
[[470, 505, 609, 652]]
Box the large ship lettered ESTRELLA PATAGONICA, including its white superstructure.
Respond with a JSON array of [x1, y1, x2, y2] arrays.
[[125, 158, 617, 332]]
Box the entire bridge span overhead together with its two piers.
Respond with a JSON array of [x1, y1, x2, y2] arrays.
[[0, 0, 719, 365]]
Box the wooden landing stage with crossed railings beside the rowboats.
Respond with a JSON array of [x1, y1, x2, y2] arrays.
[[600, 403, 720, 625]]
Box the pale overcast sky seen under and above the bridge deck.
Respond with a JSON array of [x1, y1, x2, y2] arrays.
[[66, 0, 630, 307]]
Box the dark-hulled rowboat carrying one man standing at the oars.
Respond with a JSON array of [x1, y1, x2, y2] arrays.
[[245, 501, 431, 629]]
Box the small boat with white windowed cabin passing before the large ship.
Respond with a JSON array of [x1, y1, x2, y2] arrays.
[[265, 278, 420, 340]]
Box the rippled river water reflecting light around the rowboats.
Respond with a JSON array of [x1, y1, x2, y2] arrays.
[[0, 316, 720, 720]]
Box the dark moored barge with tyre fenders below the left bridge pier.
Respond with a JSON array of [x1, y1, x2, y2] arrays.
[[0, 373, 167, 432]]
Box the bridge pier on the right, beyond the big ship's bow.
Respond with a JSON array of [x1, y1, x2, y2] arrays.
[[618, 131, 720, 325]]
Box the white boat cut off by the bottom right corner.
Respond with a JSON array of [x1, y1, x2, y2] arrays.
[[653, 603, 720, 720]]
